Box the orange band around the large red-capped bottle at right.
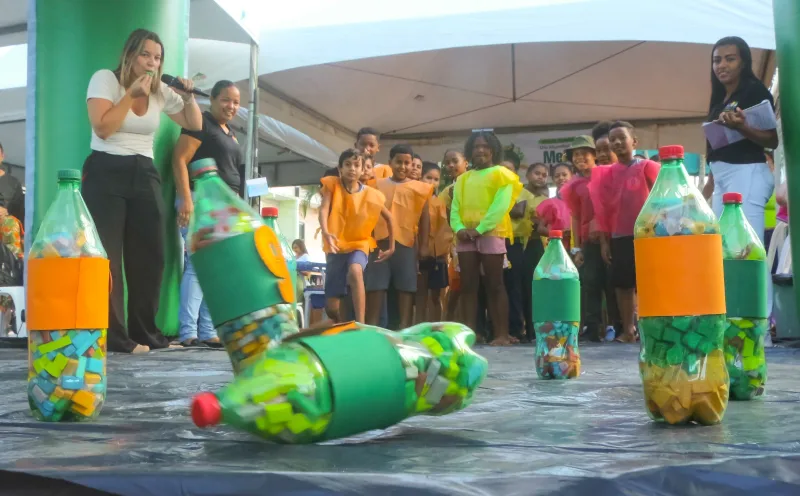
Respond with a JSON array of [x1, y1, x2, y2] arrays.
[[634, 234, 725, 317]]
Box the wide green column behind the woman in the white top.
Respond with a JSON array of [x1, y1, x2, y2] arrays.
[[25, 0, 189, 336]]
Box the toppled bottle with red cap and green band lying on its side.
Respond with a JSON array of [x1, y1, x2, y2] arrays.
[[192, 323, 487, 444]]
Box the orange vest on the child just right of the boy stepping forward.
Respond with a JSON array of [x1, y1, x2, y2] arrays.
[[375, 178, 433, 248]]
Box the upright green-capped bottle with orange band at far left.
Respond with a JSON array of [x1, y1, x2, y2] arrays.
[[27, 169, 111, 422]]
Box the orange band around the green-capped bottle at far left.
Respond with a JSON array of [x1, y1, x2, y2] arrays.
[[26, 258, 111, 331]]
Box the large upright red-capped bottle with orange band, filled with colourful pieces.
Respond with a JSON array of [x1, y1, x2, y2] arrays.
[[634, 146, 728, 425]]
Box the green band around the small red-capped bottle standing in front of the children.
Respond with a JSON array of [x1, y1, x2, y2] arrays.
[[532, 279, 581, 322]]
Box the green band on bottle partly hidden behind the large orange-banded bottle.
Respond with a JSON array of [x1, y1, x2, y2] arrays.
[[723, 260, 769, 319]]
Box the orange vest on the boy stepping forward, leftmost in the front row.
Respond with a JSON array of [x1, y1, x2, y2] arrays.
[[321, 177, 386, 254]]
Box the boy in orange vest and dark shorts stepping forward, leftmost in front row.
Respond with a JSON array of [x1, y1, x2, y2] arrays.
[[319, 148, 394, 323]]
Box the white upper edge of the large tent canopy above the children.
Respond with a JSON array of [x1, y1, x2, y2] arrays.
[[259, 0, 775, 75]]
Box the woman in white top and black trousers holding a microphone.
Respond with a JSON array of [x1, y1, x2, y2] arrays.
[[82, 29, 203, 353]]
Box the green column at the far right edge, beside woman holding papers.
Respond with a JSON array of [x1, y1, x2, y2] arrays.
[[772, 0, 800, 318]]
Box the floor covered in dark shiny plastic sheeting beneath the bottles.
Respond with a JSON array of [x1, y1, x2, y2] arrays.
[[0, 344, 800, 496]]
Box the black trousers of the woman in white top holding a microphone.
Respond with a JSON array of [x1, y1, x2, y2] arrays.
[[81, 152, 169, 353]]
